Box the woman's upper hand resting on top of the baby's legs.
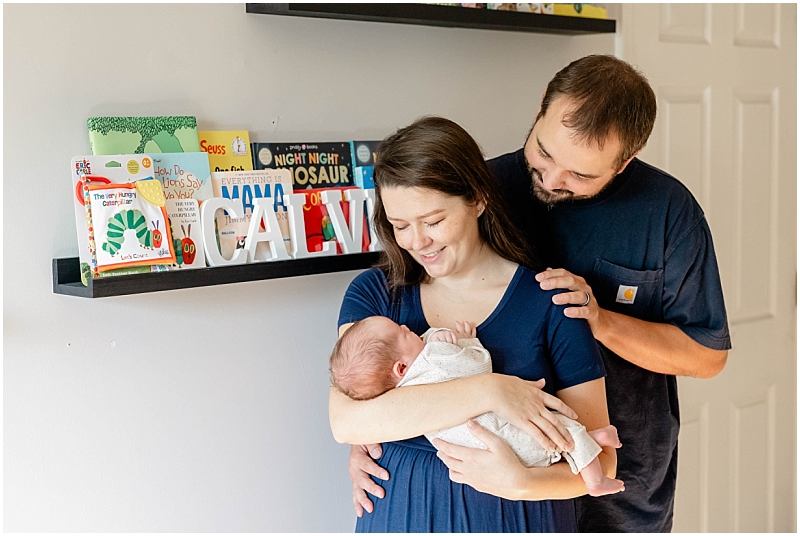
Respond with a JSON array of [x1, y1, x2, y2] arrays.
[[492, 374, 578, 452]]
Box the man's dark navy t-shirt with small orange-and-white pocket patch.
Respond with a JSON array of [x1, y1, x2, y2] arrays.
[[488, 149, 731, 532]]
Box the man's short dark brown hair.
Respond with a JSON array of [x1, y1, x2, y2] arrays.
[[536, 55, 656, 169]]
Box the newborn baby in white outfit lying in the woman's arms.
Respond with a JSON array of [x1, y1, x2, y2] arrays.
[[330, 316, 625, 497]]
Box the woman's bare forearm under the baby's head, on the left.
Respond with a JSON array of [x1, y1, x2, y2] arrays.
[[328, 374, 495, 445]]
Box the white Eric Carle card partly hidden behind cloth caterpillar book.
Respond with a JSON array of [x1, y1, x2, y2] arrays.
[[70, 154, 163, 285]]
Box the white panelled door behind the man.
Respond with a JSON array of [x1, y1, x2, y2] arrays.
[[617, 4, 797, 532]]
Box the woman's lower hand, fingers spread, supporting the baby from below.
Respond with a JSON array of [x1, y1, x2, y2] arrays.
[[433, 420, 527, 501]]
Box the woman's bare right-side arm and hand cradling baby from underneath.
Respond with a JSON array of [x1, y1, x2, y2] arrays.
[[434, 378, 617, 501]]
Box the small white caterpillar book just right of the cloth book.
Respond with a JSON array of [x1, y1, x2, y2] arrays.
[[166, 198, 206, 270]]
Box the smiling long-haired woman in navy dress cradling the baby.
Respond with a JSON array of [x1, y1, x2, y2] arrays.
[[330, 117, 616, 532]]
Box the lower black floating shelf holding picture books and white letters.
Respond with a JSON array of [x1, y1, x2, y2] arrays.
[[53, 252, 380, 298]]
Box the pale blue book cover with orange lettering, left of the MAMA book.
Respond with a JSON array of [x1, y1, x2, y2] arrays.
[[153, 152, 214, 201]]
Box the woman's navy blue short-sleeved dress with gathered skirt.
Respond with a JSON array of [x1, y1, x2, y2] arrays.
[[339, 267, 605, 532]]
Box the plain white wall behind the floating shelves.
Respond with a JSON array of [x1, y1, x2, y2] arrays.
[[3, 4, 614, 532]]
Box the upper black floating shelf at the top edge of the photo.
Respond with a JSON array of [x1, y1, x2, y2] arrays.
[[245, 4, 617, 35]]
